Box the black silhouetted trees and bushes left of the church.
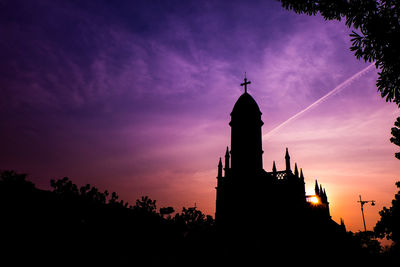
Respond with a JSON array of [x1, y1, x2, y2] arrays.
[[0, 171, 216, 266]]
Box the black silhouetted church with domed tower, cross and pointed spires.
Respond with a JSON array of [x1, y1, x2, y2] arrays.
[[215, 75, 346, 264]]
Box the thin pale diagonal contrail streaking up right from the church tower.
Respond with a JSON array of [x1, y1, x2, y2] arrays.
[[263, 63, 375, 140]]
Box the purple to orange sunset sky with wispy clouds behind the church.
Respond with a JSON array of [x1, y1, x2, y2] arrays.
[[0, 0, 400, 234]]
